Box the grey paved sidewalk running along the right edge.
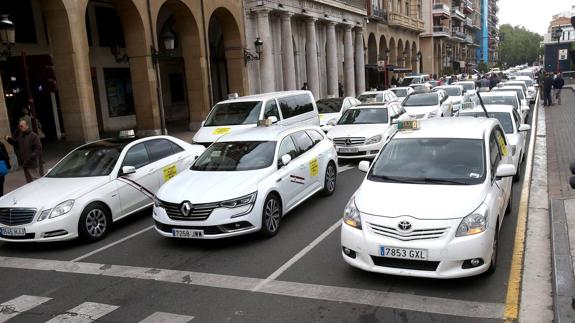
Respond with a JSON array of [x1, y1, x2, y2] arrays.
[[545, 85, 575, 322]]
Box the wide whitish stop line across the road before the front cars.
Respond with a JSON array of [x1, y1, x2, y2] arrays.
[[0, 257, 505, 319]]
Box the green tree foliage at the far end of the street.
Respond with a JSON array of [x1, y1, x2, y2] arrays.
[[499, 24, 543, 66]]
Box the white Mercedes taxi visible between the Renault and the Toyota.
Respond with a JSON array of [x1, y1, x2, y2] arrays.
[[327, 102, 405, 159]]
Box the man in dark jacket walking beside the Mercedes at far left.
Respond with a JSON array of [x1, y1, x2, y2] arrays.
[[6, 120, 44, 183]]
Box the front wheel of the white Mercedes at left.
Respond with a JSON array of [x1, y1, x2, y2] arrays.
[[78, 203, 112, 242]]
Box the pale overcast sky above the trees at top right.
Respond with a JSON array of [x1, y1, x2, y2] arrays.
[[498, 0, 575, 35]]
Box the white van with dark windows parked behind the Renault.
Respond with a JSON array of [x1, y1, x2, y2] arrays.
[[193, 91, 319, 147]]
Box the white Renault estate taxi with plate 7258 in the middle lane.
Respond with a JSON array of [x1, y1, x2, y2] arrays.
[[153, 125, 337, 239]]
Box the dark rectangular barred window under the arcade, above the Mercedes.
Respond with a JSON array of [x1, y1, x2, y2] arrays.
[[104, 68, 134, 118]]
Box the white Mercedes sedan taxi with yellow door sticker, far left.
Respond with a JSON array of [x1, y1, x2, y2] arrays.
[[0, 136, 205, 242]]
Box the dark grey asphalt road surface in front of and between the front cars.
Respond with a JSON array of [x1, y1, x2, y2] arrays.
[[0, 110, 536, 323]]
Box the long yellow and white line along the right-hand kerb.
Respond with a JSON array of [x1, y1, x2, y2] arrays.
[[504, 90, 539, 322]]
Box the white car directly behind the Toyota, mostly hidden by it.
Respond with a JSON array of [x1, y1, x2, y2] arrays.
[[458, 104, 531, 181]]
